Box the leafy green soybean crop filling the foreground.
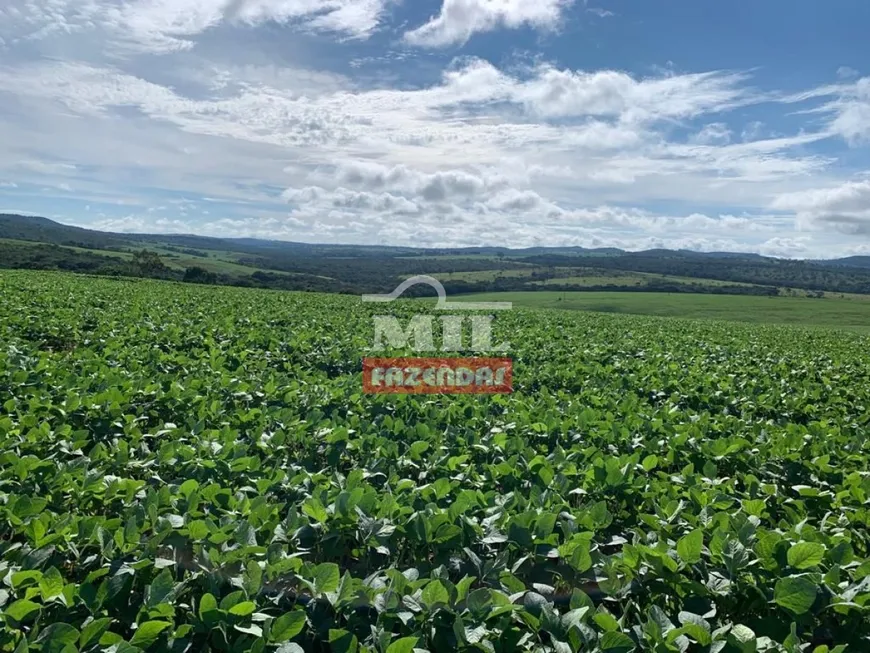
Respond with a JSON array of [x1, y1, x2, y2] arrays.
[[0, 271, 870, 653]]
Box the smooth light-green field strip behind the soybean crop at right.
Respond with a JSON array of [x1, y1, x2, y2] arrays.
[[453, 291, 870, 330]]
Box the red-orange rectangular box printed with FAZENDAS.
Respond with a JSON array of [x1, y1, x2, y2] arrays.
[[363, 358, 513, 395]]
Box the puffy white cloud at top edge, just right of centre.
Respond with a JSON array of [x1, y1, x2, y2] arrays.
[[405, 0, 574, 48]]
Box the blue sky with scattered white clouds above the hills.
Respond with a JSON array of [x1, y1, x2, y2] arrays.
[[0, 0, 870, 258]]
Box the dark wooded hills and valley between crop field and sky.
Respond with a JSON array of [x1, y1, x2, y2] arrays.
[[0, 214, 870, 295]]
